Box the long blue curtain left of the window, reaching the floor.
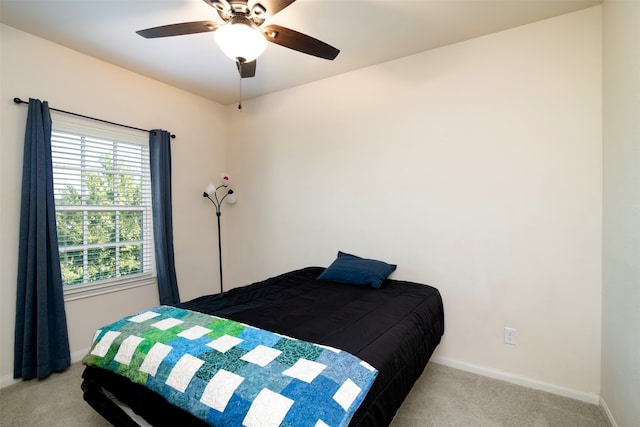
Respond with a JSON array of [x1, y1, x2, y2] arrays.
[[13, 99, 71, 380]]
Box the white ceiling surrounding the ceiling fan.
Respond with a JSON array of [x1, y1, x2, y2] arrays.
[[0, 0, 601, 104]]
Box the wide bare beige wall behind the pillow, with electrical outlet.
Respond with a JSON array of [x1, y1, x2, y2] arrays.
[[227, 7, 602, 402]]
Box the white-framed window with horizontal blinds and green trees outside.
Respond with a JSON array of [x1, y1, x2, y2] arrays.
[[51, 118, 155, 299]]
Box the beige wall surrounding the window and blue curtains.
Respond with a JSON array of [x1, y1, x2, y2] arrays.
[[0, 25, 227, 385]]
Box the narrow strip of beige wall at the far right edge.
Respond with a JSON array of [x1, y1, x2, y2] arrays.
[[601, 0, 640, 427]]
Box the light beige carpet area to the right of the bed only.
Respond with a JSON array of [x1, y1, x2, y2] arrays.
[[391, 363, 609, 427]]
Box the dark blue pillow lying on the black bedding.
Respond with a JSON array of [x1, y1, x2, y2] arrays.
[[318, 251, 396, 289]]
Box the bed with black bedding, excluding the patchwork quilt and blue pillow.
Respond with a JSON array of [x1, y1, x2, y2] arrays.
[[82, 266, 444, 427]]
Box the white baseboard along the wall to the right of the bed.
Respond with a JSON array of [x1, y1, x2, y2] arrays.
[[431, 356, 600, 406]]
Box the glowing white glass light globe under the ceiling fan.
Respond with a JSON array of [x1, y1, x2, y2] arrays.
[[213, 22, 267, 62]]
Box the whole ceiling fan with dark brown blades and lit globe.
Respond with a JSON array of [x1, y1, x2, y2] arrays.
[[136, 0, 340, 78]]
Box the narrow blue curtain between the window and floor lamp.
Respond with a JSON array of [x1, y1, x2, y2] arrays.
[[149, 129, 180, 304]]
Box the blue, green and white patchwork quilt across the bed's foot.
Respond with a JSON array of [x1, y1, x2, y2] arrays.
[[83, 306, 378, 427]]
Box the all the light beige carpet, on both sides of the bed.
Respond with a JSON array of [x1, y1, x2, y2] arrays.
[[0, 363, 608, 427]]
